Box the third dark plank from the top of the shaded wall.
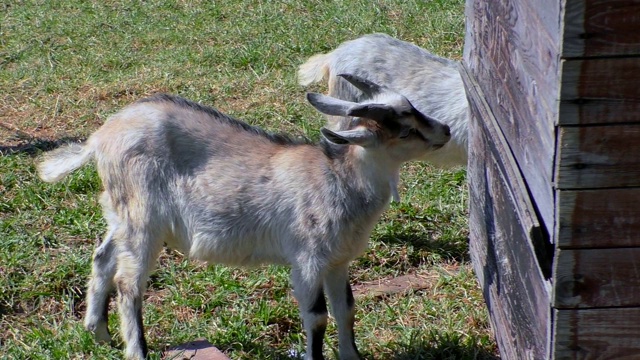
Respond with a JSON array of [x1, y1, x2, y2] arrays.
[[556, 124, 640, 189]]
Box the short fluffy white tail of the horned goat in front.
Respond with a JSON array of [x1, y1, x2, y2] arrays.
[[37, 143, 93, 183]]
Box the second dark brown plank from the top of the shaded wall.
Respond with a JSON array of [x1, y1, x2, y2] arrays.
[[559, 58, 640, 125]]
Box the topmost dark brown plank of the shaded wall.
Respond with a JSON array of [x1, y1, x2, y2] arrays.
[[562, 0, 640, 57]]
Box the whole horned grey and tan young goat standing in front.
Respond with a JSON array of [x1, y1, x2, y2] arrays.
[[38, 75, 450, 360]]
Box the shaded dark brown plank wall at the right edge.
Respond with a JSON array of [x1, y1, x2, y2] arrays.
[[552, 0, 640, 359]]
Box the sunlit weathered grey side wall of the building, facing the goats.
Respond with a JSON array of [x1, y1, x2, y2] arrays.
[[461, 0, 561, 359]]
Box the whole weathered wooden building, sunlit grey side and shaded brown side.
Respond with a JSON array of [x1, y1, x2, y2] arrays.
[[461, 0, 640, 360]]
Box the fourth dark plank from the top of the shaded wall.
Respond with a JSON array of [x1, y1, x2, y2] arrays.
[[556, 188, 640, 248]]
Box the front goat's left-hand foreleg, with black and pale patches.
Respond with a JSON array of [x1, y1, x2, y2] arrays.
[[291, 268, 328, 360]]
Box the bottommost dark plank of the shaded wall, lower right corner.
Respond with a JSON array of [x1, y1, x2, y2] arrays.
[[553, 308, 640, 360]]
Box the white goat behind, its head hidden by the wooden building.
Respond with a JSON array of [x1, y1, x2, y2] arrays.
[[298, 34, 469, 167]]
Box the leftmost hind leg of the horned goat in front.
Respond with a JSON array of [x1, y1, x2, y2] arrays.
[[84, 228, 116, 343]]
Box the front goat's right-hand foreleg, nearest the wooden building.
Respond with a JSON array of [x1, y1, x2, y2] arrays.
[[324, 263, 360, 360]]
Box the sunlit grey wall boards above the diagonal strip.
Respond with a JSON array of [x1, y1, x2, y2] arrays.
[[464, 0, 561, 229]]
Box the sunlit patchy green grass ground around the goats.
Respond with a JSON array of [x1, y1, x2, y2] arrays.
[[0, 0, 497, 359]]
